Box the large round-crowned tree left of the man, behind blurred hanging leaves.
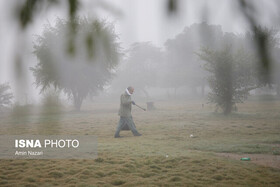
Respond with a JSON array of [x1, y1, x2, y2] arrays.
[[31, 18, 120, 110]]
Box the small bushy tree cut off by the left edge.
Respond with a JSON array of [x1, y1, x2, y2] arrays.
[[0, 83, 13, 112]]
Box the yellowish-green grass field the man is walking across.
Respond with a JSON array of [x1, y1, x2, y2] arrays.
[[0, 100, 280, 187]]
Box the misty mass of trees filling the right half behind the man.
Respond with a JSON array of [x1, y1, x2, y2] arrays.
[[112, 22, 280, 114]]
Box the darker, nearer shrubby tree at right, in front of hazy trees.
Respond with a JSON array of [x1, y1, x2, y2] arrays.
[[198, 46, 256, 115]]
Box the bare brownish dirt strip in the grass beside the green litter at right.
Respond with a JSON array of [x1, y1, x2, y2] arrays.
[[216, 153, 280, 169]]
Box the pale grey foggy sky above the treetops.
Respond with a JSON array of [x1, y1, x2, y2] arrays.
[[0, 0, 279, 102]]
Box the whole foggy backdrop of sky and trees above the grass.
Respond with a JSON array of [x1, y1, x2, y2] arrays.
[[0, 0, 280, 113]]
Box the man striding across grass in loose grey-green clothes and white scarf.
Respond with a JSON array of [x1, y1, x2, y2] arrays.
[[115, 86, 141, 138]]
